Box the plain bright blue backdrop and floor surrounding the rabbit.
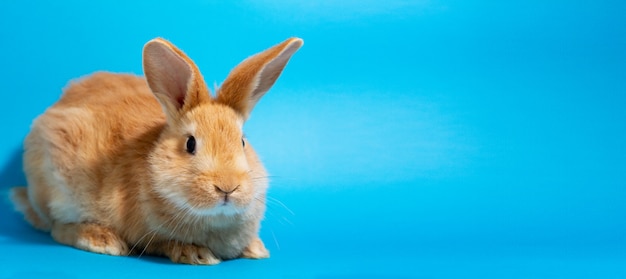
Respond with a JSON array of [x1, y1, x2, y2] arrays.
[[0, 0, 626, 278]]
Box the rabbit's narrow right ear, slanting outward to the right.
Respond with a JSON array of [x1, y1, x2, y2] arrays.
[[217, 38, 303, 119]]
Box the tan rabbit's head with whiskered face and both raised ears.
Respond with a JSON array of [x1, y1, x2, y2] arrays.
[[143, 38, 303, 216]]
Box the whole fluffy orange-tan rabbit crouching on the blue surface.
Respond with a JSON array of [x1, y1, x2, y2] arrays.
[[11, 38, 303, 265]]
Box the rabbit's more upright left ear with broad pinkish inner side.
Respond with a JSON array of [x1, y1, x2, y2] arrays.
[[143, 38, 210, 119]]
